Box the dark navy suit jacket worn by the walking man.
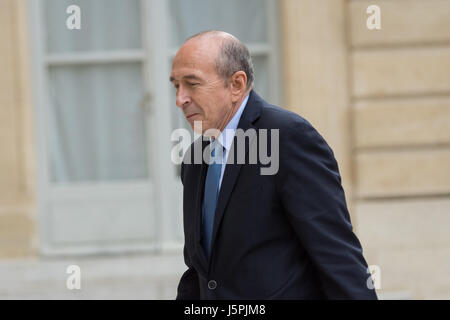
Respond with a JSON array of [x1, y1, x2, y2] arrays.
[[177, 91, 377, 299]]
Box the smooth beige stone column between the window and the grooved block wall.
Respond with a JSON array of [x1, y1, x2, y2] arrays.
[[280, 0, 353, 218]]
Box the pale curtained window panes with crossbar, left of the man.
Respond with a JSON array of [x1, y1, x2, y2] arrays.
[[43, 0, 151, 183]]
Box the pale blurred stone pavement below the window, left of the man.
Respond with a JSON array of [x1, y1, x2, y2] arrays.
[[0, 253, 186, 300]]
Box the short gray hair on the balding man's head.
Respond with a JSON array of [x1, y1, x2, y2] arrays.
[[186, 30, 254, 90]]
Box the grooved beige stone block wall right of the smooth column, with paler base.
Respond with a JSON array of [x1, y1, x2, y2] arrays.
[[348, 0, 450, 299]]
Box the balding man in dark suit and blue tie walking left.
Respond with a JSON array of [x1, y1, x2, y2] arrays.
[[170, 31, 377, 299]]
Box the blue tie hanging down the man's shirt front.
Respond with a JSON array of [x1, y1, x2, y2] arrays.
[[202, 143, 223, 258]]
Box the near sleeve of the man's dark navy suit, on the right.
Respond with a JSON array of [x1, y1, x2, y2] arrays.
[[277, 121, 377, 299]]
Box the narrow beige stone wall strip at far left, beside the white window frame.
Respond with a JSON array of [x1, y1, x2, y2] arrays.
[[0, 0, 36, 258]]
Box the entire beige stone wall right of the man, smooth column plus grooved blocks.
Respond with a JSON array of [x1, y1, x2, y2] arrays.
[[282, 0, 450, 299]]
